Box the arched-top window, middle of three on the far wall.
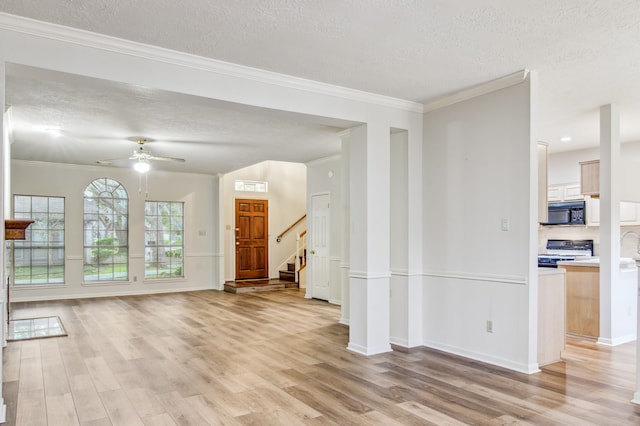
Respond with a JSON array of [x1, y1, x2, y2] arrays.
[[84, 178, 129, 281]]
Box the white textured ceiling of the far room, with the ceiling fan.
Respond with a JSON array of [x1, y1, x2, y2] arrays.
[[6, 64, 349, 173]]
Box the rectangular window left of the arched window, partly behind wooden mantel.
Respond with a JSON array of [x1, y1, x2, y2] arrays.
[[13, 195, 64, 285]]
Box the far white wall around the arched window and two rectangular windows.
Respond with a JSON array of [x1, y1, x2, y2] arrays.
[[11, 161, 222, 302]]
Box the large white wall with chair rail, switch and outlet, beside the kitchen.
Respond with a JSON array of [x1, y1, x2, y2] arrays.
[[423, 80, 537, 372]]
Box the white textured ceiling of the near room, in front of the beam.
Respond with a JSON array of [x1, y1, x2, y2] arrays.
[[0, 0, 640, 172]]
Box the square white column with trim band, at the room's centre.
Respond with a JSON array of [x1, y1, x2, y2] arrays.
[[347, 122, 391, 355]]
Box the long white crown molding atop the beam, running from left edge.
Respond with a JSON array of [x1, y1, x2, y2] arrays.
[[0, 12, 423, 113]]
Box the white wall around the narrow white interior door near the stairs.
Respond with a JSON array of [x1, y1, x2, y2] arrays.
[[307, 155, 343, 305]]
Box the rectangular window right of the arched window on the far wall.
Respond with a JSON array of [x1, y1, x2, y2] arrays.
[[144, 201, 184, 278]]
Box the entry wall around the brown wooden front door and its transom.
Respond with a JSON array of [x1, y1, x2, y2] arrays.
[[223, 161, 307, 281]]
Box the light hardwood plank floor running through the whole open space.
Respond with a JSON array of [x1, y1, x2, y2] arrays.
[[4, 289, 640, 426]]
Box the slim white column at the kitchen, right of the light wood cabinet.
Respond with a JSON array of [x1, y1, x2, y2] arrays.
[[598, 105, 621, 345]]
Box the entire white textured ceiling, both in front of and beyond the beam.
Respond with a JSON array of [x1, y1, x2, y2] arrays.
[[0, 0, 640, 172]]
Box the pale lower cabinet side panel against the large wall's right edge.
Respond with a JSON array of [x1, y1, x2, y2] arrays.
[[538, 268, 565, 365]]
